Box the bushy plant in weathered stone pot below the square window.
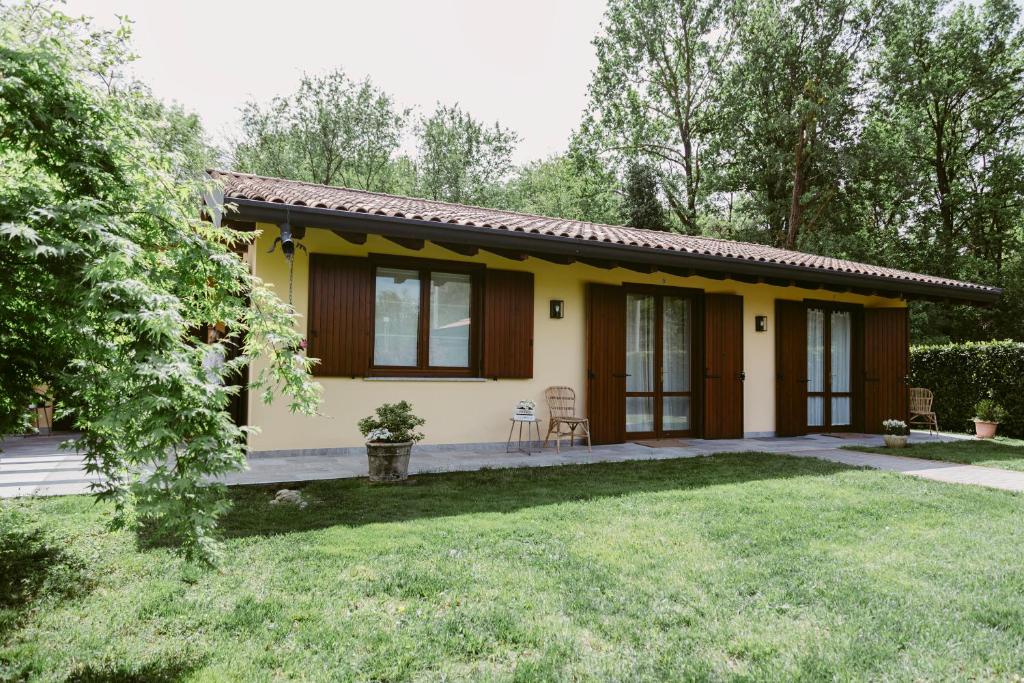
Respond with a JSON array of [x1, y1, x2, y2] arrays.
[[358, 400, 426, 481]]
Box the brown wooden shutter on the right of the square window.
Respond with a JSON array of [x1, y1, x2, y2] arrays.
[[483, 268, 534, 379]]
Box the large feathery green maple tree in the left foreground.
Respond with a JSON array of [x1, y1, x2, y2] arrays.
[[0, 3, 317, 559]]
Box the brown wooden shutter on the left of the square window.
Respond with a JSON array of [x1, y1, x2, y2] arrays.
[[308, 254, 374, 377]]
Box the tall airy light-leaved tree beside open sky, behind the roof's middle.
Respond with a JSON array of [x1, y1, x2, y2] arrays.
[[581, 0, 731, 233]]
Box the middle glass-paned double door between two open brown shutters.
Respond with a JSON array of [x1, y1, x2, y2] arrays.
[[626, 292, 693, 438]]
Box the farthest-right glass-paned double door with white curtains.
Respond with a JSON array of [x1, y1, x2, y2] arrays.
[[807, 307, 853, 431]]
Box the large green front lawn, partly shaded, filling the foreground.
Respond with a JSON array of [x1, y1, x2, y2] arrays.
[[0, 454, 1024, 681]]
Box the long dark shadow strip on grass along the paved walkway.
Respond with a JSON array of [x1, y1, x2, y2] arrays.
[[222, 453, 853, 538]]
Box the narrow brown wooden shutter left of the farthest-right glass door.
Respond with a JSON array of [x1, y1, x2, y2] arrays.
[[775, 300, 807, 436]]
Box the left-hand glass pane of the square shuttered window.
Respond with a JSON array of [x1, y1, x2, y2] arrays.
[[374, 268, 420, 367]]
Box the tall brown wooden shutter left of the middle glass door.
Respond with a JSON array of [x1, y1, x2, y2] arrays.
[[587, 285, 626, 443]]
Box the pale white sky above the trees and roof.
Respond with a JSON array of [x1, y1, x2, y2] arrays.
[[66, 0, 604, 163]]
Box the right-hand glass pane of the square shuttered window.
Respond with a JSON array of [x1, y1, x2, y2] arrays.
[[430, 272, 472, 368]]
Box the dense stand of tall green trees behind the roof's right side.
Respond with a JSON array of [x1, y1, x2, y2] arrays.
[[572, 0, 1024, 341]]
